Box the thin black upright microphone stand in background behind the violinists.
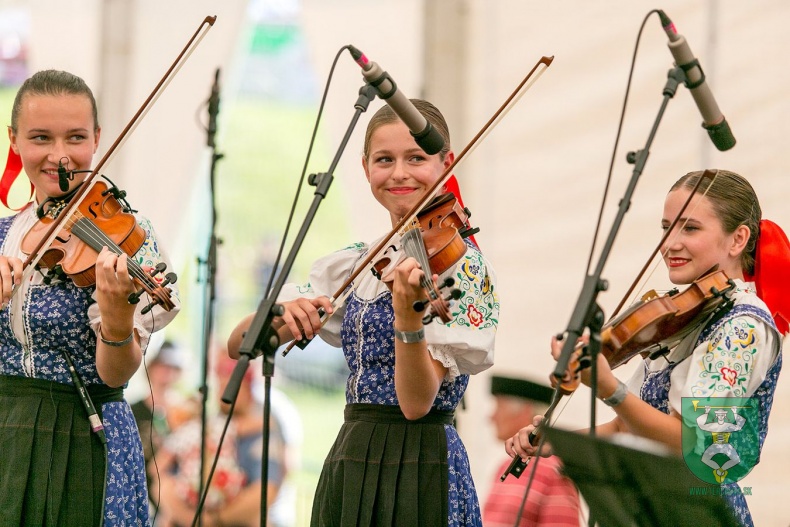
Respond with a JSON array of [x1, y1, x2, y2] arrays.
[[197, 68, 224, 520]]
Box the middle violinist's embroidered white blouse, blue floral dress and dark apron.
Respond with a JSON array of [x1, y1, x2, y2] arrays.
[[283, 237, 499, 526]]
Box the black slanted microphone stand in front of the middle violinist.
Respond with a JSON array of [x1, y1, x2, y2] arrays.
[[222, 83, 376, 527]]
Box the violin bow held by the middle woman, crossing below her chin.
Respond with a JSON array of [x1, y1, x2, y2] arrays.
[[283, 55, 554, 355]]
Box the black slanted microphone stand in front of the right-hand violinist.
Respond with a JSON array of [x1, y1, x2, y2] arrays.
[[553, 67, 686, 446]]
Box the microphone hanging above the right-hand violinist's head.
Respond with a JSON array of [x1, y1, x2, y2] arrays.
[[658, 10, 735, 151]]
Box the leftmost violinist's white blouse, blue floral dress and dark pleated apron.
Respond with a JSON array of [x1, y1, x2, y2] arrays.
[[0, 202, 179, 526]]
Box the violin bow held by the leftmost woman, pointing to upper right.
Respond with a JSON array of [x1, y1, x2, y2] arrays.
[[18, 16, 217, 294]]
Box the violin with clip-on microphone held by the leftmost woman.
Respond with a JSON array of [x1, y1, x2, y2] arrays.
[[22, 181, 177, 313]]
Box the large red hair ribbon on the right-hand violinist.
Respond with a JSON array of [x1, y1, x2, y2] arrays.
[[746, 220, 790, 334]]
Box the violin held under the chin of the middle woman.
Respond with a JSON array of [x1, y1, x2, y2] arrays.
[[371, 192, 479, 324]]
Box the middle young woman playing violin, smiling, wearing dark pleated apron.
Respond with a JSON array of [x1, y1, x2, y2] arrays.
[[228, 100, 499, 526]]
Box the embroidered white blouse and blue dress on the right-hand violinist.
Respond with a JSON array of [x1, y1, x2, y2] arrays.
[[628, 280, 782, 526]]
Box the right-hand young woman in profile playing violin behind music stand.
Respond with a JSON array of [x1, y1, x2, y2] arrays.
[[505, 170, 790, 525]]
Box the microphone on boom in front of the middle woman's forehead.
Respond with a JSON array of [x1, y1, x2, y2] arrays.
[[348, 45, 444, 155]]
